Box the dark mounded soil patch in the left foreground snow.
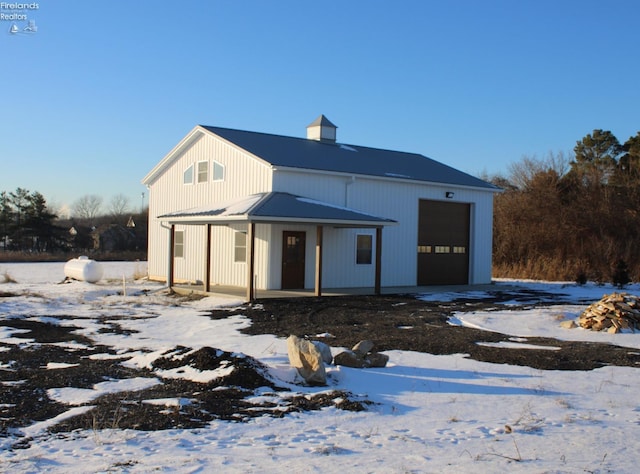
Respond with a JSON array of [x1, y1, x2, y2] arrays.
[[0, 318, 368, 449]]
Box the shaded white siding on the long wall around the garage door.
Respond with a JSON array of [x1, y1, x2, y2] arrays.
[[273, 169, 493, 288]]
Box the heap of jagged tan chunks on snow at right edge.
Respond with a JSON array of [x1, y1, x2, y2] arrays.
[[578, 293, 640, 333]]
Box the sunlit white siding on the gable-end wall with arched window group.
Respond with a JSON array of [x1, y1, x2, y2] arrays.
[[148, 128, 271, 285]]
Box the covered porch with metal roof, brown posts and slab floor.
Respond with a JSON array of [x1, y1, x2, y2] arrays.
[[159, 192, 397, 301]]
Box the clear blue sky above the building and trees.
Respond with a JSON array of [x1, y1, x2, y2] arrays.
[[0, 0, 640, 213]]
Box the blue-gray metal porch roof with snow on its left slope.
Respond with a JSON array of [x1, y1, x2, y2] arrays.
[[158, 192, 396, 227]]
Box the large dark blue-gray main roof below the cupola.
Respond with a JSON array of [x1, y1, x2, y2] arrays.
[[202, 125, 499, 191]]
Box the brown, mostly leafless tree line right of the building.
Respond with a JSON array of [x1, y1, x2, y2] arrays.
[[491, 130, 640, 282]]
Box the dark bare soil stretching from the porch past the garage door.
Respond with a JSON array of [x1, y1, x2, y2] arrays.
[[212, 292, 640, 370]]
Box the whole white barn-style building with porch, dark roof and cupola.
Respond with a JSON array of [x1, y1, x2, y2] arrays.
[[142, 115, 498, 299]]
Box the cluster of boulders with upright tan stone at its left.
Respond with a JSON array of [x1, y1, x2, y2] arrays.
[[287, 335, 389, 385]]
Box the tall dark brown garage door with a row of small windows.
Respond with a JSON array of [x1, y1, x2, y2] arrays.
[[418, 200, 470, 285]]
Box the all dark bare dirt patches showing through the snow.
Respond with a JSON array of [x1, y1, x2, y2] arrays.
[[0, 286, 640, 448]]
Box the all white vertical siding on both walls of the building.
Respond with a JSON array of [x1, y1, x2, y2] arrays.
[[144, 122, 495, 290]]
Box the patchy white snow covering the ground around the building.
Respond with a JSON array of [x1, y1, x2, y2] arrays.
[[0, 263, 640, 473]]
